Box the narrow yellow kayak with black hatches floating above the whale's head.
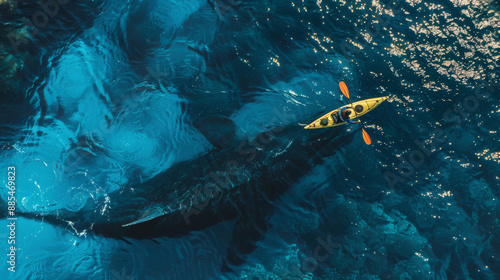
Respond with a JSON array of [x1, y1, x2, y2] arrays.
[[304, 96, 389, 129]]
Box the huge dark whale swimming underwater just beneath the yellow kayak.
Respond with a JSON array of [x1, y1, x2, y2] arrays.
[[18, 115, 352, 267]]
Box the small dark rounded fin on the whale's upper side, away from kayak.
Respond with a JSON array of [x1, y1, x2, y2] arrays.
[[194, 116, 236, 149]]
